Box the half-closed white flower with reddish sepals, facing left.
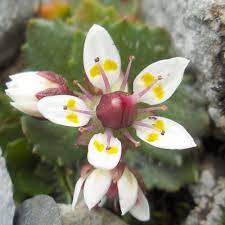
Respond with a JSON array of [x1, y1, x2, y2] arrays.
[[5, 71, 70, 117]]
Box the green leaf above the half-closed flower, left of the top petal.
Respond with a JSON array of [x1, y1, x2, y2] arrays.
[[23, 19, 77, 86]]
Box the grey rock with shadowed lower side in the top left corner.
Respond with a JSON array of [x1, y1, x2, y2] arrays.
[[0, 0, 40, 67]]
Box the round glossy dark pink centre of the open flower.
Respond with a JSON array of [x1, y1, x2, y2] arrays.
[[96, 91, 137, 129]]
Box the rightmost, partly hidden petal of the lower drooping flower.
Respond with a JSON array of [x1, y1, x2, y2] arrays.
[[130, 188, 150, 221]]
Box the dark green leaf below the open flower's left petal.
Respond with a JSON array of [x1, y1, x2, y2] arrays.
[[22, 116, 86, 165]]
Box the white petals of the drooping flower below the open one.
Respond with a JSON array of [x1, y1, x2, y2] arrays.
[[72, 167, 150, 221]]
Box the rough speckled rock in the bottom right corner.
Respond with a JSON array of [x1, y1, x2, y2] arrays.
[[183, 158, 225, 225]]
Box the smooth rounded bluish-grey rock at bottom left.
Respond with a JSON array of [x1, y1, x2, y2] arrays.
[[14, 195, 62, 225]]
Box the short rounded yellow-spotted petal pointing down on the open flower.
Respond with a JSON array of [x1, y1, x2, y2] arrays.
[[87, 134, 122, 170]]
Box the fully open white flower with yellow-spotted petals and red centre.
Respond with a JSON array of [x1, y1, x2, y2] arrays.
[[34, 25, 196, 169]]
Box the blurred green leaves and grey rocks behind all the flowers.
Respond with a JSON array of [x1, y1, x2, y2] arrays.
[[0, 0, 225, 225]]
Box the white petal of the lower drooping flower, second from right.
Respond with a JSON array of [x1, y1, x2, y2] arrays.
[[117, 168, 138, 215]]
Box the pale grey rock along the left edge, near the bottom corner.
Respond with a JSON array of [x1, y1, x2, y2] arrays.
[[0, 148, 15, 225]]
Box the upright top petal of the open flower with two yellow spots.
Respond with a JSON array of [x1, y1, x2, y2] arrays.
[[83, 24, 121, 90]]
